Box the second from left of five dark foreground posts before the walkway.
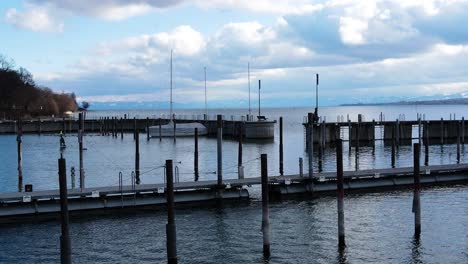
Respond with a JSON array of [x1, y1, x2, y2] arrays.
[[166, 160, 177, 264]]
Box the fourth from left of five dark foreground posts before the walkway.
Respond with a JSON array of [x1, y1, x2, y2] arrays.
[[336, 139, 345, 249]]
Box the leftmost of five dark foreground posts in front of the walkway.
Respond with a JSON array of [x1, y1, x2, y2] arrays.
[[58, 157, 72, 264]]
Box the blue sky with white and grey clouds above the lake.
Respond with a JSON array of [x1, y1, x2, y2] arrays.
[[0, 0, 468, 108]]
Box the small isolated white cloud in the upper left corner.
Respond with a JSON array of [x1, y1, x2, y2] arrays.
[[5, 5, 64, 32]]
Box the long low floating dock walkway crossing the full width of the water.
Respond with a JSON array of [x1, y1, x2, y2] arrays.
[[0, 164, 468, 222]]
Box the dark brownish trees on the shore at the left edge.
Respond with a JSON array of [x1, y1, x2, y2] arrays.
[[0, 55, 78, 119]]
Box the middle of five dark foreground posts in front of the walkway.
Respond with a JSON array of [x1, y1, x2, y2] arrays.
[[260, 154, 270, 258]]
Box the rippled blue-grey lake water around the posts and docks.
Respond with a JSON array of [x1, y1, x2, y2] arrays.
[[0, 105, 468, 263]]
